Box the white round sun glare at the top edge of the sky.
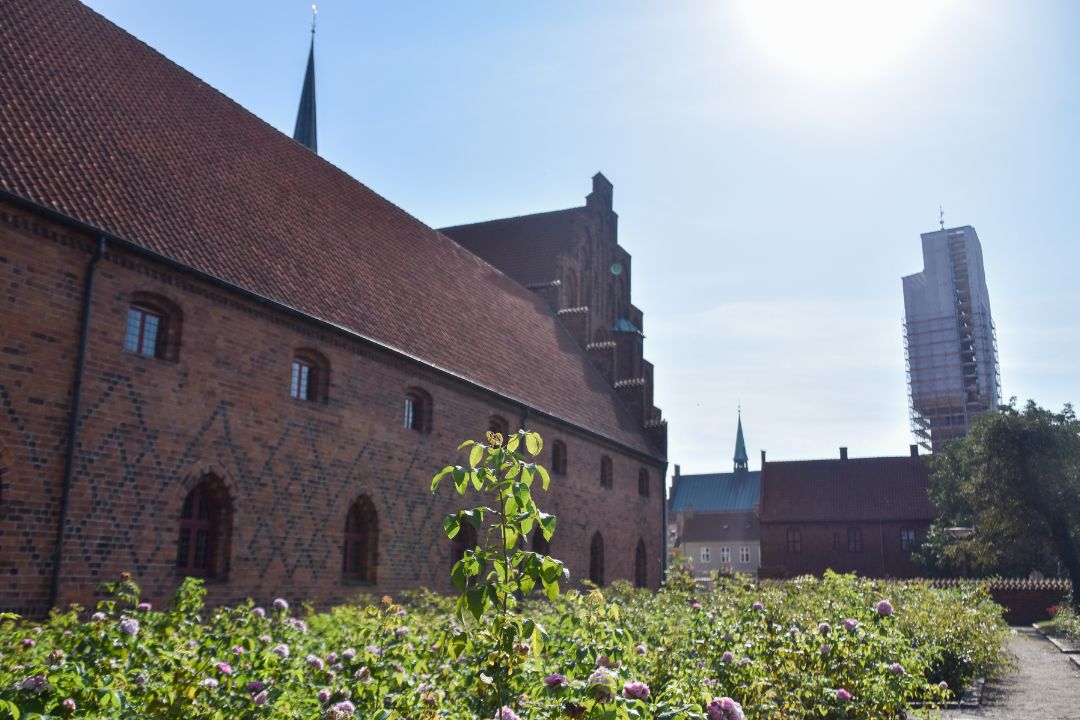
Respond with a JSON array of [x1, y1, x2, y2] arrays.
[[737, 0, 953, 84]]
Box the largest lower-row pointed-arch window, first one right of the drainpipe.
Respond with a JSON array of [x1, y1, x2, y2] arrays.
[[176, 475, 232, 578]]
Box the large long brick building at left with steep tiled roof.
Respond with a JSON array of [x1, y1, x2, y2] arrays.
[[0, 0, 666, 613]]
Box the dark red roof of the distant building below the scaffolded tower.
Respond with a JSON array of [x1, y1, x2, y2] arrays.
[[758, 456, 937, 522]]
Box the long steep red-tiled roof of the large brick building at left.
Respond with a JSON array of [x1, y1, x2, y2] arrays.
[[0, 0, 657, 456]]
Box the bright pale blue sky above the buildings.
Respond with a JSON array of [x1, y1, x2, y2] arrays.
[[87, 0, 1080, 474]]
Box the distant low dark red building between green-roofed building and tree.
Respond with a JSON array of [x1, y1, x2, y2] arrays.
[[759, 446, 937, 578]]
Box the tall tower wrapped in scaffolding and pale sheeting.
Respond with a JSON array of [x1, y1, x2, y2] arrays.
[[902, 221, 1001, 451]]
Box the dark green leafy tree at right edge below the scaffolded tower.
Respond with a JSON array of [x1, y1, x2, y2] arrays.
[[920, 402, 1080, 603]]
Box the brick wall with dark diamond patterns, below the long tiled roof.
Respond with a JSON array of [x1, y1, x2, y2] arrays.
[[0, 199, 663, 613]]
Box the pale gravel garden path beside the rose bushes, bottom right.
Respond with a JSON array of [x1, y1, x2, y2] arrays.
[[941, 627, 1080, 720]]
